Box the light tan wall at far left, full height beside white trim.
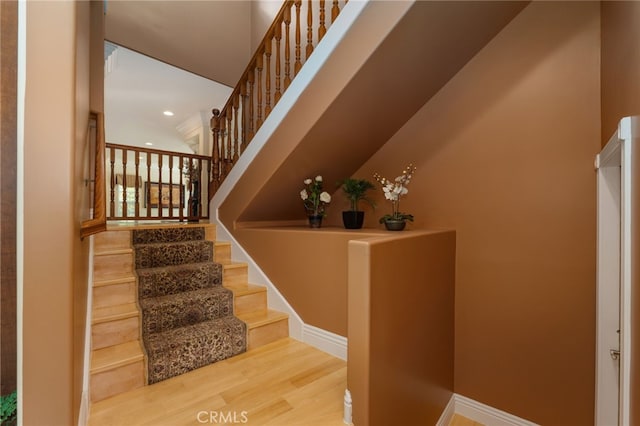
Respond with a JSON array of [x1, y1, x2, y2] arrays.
[[19, 1, 89, 425]]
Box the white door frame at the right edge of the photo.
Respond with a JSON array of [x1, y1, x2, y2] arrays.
[[595, 117, 640, 425]]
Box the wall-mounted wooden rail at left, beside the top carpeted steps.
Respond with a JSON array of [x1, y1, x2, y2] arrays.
[[80, 112, 107, 238]]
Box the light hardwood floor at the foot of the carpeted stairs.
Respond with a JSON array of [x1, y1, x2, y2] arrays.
[[89, 338, 347, 426]]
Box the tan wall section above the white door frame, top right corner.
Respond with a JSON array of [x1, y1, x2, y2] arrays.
[[601, 1, 640, 146]]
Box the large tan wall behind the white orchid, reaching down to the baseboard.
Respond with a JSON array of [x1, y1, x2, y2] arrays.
[[356, 2, 600, 425]]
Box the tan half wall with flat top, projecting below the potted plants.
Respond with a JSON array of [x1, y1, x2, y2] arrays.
[[348, 231, 456, 425]]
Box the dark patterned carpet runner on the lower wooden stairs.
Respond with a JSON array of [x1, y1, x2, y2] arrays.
[[133, 227, 247, 384]]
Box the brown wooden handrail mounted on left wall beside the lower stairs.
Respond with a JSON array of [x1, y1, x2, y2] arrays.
[[80, 111, 107, 238]]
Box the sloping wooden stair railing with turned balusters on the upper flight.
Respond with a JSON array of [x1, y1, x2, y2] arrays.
[[209, 0, 348, 199]]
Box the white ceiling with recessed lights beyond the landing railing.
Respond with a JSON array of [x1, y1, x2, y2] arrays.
[[104, 42, 232, 153]]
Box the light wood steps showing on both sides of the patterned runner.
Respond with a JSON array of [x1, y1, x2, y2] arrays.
[[90, 224, 289, 402]]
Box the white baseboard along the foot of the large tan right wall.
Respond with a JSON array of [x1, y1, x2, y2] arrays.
[[436, 393, 539, 426]]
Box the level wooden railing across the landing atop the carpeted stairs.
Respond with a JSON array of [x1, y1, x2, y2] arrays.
[[103, 143, 211, 221]]
